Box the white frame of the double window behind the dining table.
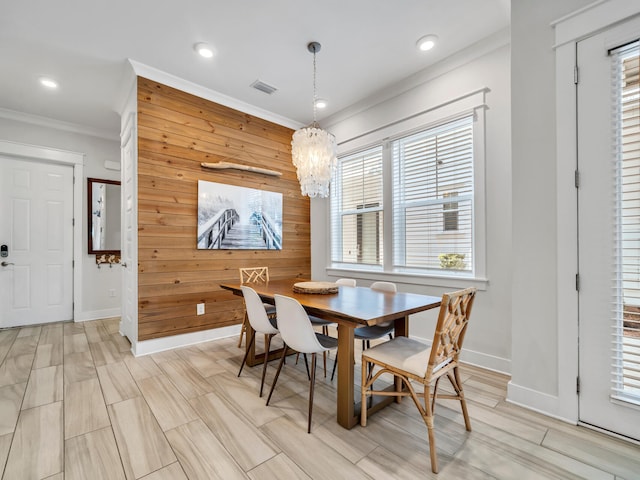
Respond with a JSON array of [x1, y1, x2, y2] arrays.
[[325, 88, 488, 290]]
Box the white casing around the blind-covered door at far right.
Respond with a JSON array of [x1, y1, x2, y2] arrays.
[[551, 0, 640, 423]]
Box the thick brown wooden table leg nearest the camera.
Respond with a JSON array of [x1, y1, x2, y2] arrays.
[[336, 324, 358, 429]]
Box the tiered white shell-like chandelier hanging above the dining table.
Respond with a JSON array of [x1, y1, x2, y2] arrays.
[[291, 42, 337, 197]]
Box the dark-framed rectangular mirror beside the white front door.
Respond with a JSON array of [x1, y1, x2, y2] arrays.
[[87, 178, 121, 255]]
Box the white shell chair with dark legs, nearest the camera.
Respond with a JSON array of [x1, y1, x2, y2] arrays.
[[267, 294, 338, 433]]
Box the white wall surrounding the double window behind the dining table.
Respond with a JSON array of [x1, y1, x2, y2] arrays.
[[311, 32, 511, 372]]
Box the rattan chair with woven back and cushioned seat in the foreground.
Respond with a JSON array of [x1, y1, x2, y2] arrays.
[[360, 288, 476, 473]]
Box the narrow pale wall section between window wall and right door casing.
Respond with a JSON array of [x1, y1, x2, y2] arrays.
[[508, 0, 592, 421]]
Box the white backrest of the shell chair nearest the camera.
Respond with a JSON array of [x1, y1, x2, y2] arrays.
[[274, 295, 324, 353]]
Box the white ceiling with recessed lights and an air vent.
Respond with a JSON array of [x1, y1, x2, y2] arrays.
[[0, 0, 510, 137]]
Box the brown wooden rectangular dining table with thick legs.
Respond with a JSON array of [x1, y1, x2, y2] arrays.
[[220, 278, 441, 429]]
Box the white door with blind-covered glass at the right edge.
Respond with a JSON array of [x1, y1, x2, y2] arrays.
[[577, 18, 640, 439]]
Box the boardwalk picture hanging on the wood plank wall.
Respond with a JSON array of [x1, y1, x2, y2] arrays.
[[197, 180, 282, 250]]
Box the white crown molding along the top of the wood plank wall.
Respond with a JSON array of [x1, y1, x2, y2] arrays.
[[129, 59, 304, 130]]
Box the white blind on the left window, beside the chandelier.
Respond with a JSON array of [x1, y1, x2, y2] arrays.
[[331, 146, 384, 266]]
